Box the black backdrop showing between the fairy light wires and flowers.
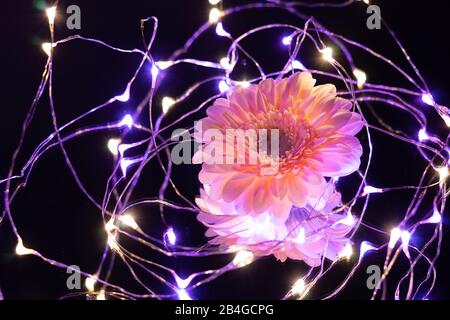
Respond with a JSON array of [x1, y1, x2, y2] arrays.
[[0, 0, 450, 299]]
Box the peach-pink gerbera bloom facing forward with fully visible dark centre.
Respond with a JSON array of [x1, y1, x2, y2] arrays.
[[193, 72, 363, 223]]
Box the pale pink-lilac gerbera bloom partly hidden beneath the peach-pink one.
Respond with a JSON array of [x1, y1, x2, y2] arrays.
[[196, 183, 353, 266]]
